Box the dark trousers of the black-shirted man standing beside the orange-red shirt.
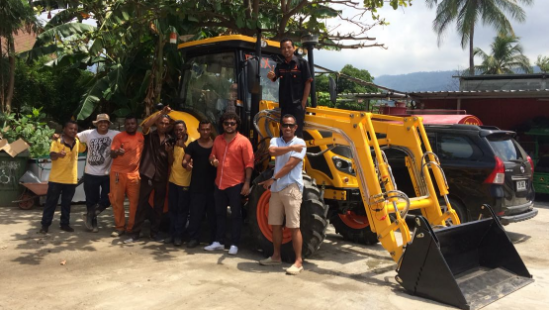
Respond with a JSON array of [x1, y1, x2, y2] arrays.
[[188, 192, 217, 243]]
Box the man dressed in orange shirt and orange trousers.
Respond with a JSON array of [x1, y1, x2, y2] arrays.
[[109, 114, 145, 237]]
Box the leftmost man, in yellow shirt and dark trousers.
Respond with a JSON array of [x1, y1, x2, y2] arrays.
[[40, 121, 86, 234]]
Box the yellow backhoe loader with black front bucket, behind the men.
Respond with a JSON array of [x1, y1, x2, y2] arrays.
[[149, 35, 533, 309]]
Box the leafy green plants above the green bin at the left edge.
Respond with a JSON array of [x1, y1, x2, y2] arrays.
[[0, 108, 54, 157]]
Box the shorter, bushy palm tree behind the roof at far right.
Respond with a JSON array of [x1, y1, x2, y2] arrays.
[[474, 33, 532, 74]]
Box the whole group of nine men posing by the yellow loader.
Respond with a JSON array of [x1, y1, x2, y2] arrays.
[[40, 39, 312, 274]]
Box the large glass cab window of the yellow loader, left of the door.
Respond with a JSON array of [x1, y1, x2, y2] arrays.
[[181, 52, 237, 124]]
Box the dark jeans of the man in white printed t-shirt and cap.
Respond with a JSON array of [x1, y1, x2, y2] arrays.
[[84, 173, 111, 212]]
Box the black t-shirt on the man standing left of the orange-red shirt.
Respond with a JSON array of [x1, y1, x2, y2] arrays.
[[185, 140, 217, 195]]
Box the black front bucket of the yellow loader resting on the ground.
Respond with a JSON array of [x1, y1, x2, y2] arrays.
[[397, 206, 534, 309]]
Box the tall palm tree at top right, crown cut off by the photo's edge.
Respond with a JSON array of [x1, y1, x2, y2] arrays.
[[426, 0, 533, 75]]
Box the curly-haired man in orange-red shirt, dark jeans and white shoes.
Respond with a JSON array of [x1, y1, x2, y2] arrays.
[[204, 112, 254, 255]]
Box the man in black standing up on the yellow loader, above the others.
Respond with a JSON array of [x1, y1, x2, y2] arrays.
[[267, 38, 313, 138]]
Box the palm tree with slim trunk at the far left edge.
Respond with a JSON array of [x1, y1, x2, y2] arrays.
[[0, 0, 36, 113]]
